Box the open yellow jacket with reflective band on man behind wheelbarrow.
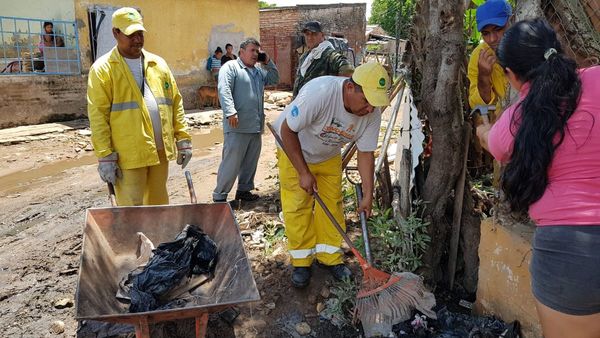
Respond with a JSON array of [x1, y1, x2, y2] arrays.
[[87, 47, 191, 169]]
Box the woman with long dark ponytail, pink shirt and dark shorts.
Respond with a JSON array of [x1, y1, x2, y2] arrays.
[[477, 19, 600, 338]]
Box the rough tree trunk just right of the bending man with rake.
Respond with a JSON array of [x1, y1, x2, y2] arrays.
[[411, 0, 479, 286]]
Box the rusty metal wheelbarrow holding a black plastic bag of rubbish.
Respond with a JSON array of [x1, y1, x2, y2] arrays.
[[75, 172, 260, 338]]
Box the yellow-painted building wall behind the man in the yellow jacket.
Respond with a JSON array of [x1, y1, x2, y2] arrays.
[[74, 0, 259, 109]]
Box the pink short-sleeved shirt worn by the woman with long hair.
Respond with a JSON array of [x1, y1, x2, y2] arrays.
[[488, 66, 600, 225]]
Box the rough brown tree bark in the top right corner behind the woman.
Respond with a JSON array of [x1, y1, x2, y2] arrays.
[[542, 0, 600, 67]]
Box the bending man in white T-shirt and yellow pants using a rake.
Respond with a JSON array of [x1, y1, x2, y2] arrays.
[[274, 62, 390, 287]]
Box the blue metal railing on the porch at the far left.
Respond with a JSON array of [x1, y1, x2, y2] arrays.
[[0, 16, 81, 75]]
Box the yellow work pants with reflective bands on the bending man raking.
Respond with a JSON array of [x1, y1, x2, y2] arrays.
[[277, 150, 346, 267]]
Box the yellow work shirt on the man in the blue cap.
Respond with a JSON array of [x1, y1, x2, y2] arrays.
[[467, 42, 509, 113]]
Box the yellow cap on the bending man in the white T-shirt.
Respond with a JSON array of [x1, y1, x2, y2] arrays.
[[352, 62, 390, 107]]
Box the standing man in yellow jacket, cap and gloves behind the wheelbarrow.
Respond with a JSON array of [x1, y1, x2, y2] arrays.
[[87, 7, 192, 205]]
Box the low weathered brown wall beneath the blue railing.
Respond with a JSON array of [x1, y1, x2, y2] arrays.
[[0, 75, 86, 129]]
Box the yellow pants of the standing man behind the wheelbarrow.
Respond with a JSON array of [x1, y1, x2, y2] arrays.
[[115, 150, 169, 206]]
